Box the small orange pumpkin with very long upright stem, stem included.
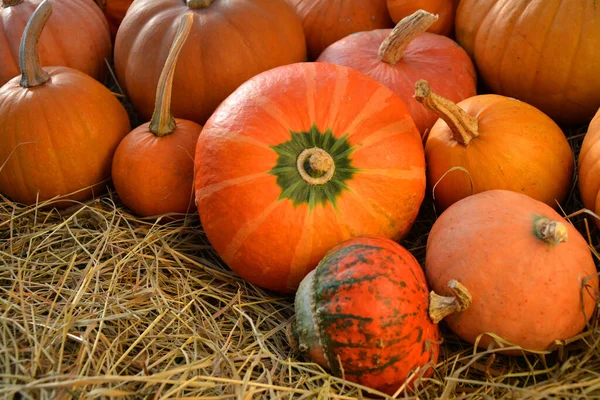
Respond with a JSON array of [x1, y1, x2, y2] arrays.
[[112, 12, 202, 217]]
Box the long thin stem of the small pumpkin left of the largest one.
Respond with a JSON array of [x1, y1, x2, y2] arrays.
[[149, 11, 194, 137]]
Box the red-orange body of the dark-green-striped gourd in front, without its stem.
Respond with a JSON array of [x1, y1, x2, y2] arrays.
[[295, 236, 440, 395]]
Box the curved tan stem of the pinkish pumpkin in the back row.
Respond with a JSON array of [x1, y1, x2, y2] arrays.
[[378, 10, 439, 64]]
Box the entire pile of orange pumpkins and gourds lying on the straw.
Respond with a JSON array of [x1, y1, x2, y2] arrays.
[[0, 0, 600, 394]]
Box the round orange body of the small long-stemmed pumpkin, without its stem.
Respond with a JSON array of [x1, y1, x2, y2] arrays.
[[112, 119, 202, 217]]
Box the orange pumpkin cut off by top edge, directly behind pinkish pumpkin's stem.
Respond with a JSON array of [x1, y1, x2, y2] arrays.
[[387, 0, 458, 36]]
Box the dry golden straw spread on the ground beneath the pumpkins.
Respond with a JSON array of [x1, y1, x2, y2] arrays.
[[0, 79, 600, 400]]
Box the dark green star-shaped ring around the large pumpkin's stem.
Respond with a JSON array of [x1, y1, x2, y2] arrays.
[[270, 124, 358, 209]]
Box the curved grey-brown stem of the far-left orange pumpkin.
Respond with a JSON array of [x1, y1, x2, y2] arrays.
[[19, 0, 52, 88]]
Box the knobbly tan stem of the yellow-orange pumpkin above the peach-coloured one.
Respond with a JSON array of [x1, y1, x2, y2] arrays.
[[415, 79, 479, 146]]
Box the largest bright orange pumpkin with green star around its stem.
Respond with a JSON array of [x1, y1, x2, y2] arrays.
[[195, 63, 425, 293]]
